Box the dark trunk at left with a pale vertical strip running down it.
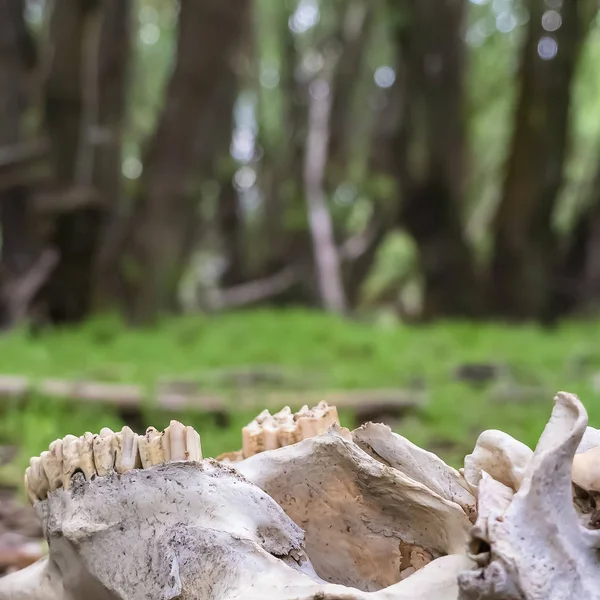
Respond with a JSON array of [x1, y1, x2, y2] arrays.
[[44, 0, 131, 323]]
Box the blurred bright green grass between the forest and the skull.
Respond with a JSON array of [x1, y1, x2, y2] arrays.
[[0, 310, 600, 494]]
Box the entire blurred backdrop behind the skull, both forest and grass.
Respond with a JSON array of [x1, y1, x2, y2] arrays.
[[0, 0, 600, 490]]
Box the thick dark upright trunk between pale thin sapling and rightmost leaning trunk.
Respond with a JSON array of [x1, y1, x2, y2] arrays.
[[390, 0, 479, 319]]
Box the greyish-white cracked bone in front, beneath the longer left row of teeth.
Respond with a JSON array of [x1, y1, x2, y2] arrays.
[[0, 459, 472, 600]]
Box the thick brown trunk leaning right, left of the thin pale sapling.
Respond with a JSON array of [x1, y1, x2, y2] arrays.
[[127, 0, 250, 323]]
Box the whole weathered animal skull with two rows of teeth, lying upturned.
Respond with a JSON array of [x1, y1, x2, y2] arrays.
[[0, 393, 600, 600]]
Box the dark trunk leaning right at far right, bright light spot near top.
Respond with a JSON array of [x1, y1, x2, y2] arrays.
[[490, 0, 582, 319]]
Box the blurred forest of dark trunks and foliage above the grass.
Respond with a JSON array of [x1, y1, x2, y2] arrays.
[[0, 0, 600, 328]]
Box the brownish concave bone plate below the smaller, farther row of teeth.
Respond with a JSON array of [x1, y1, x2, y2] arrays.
[[236, 426, 471, 591]]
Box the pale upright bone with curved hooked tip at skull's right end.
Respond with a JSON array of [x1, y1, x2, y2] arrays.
[[459, 392, 600, 600]]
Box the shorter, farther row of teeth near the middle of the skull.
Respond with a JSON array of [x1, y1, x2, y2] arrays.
[[240, 401, 339, 458]]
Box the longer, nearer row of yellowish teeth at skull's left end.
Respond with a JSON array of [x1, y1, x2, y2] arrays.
[[25, 421, 202, 503]]
